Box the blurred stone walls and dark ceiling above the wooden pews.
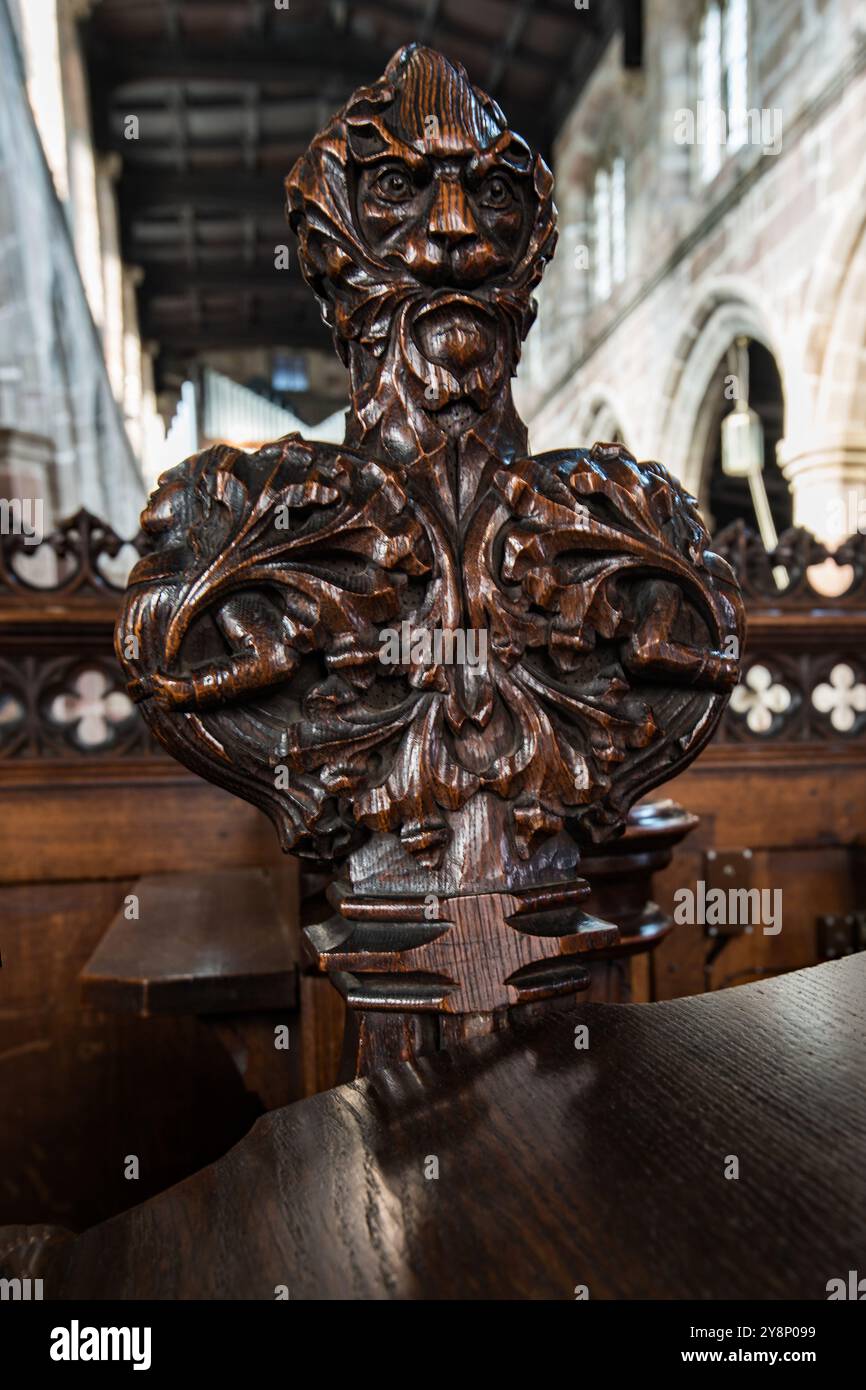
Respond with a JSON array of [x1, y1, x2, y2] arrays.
[[0, 0, 866, 541]]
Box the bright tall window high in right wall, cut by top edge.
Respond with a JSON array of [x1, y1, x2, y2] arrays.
[[696, 0, 749, 182]]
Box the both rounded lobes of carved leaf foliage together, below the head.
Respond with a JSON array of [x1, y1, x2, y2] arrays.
[[118, 439, 737, 866]]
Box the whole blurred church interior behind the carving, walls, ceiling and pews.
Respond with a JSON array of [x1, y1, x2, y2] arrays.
[[0, 0, 866, 1226]]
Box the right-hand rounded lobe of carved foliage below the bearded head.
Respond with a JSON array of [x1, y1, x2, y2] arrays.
[[453, 446, 742, 853]]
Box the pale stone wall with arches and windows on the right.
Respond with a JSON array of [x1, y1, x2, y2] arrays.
[[518, 0, 866, 539]]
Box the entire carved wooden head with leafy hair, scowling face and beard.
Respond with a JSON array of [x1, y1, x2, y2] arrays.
[[286, 44, 556, 391]]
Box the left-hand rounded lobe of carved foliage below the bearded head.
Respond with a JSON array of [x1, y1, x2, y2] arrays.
[[117, 436, 428, 852]]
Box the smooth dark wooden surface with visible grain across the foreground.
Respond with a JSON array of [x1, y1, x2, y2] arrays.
[[8, 956, 866, 1300]]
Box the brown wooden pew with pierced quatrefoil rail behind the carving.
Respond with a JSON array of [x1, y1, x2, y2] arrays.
[[0, 514, 866, 1220]]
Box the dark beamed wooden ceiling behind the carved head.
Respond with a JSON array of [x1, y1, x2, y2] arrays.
[[85, 0, 641, 379]]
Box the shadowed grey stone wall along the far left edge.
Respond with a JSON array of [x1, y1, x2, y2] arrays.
[[0, 0, 145, 534]]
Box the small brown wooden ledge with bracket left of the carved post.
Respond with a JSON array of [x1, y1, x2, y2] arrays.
[[81, 869, 343, 1109]]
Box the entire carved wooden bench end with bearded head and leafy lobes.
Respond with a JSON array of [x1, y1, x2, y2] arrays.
[[117, 46, 742, 1039]]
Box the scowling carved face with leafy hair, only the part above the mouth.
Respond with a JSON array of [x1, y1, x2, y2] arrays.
[[286, 49, 555, 307]]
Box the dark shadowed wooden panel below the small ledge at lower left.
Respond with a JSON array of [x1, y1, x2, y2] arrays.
[[0, 881, 260, 1230]]
